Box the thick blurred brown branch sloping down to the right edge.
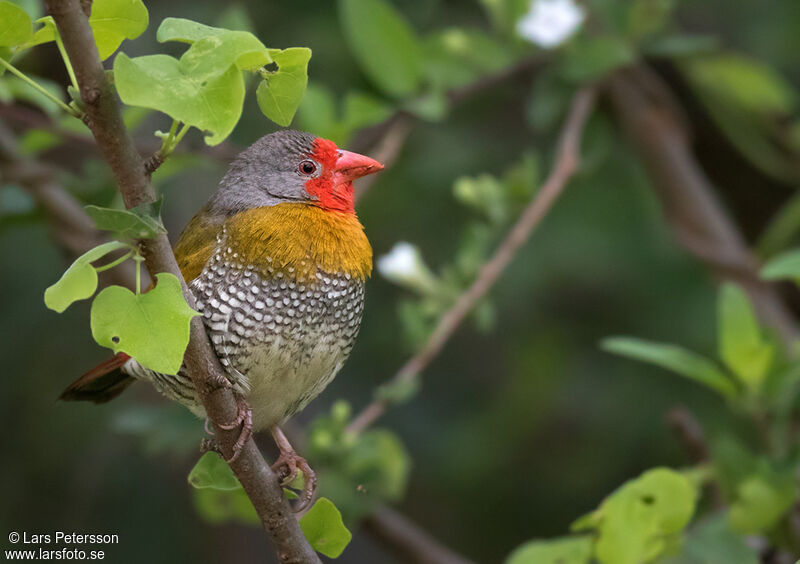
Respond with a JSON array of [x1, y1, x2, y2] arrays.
[[605, 67, 798, 349]]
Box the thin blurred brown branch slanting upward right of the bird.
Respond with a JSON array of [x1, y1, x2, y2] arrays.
[[348, 88, 595, 432]]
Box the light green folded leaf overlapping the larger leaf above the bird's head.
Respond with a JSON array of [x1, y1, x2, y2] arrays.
[[156, 18, 278, 80]]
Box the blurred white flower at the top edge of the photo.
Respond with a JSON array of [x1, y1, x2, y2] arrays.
[[517, 0, 585, 49]]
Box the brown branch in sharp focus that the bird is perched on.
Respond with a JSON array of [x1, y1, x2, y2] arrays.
[[46, 0, 319, 562]]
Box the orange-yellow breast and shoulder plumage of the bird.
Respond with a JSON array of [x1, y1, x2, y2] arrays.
[[175, 203, 372, 281]]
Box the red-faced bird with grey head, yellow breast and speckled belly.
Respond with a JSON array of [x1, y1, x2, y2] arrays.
[[60, 129, 383, 508]]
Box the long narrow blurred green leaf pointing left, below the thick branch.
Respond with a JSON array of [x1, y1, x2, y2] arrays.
[[600, 337, 737, 399]]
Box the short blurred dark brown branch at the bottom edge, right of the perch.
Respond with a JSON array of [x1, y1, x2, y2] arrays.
[[363, 506, 470, 564]]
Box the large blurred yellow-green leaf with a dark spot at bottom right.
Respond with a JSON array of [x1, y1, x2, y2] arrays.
[[595, 468, 697, 564]]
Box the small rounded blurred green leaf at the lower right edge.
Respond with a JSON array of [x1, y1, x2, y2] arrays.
[[728, 469, 797, 535]]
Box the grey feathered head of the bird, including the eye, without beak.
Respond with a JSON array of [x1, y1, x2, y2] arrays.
[[207, 129, 337, 216]]
